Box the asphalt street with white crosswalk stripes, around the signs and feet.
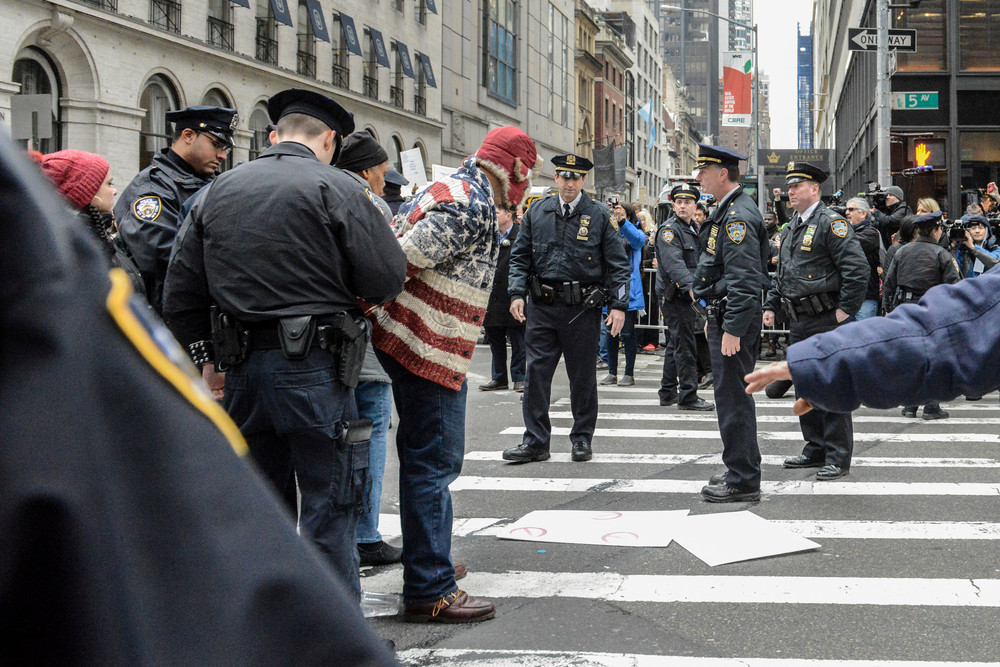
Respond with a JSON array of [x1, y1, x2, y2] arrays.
[[362, 346, 1000, 667]]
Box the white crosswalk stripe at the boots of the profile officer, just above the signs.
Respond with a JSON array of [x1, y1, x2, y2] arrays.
[[450, 475, 1000, 496]]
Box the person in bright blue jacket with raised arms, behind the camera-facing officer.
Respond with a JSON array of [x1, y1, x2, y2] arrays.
[[601, 204, 646, 387]]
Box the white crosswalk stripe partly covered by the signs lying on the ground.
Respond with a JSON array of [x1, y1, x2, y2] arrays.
[[379, 514, 1000, 540]]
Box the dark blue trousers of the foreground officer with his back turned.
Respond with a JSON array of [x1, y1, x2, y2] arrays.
[[222, 348, 369, 600]]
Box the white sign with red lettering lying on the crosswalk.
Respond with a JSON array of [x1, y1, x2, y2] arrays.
[[499, 510, 688, 547]]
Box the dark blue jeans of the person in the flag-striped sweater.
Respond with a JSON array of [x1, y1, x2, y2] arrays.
[[375, 350, 468, 605]]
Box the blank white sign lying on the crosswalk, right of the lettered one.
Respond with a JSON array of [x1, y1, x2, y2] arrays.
[[671, 512, 820, 567]]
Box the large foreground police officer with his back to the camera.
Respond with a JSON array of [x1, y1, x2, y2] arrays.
[[164, 89, 406, 595]]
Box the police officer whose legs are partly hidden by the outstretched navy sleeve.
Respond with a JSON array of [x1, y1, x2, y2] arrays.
[[764, 162, 871, 480]]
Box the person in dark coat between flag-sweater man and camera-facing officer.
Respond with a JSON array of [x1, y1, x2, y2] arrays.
[[479, 206, 525, 393]]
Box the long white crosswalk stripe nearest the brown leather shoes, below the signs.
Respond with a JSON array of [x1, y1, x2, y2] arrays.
[[364, 568, 1000, 608]]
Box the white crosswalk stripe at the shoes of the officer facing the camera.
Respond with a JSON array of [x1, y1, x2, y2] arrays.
[[465, 450, 1000, 468]]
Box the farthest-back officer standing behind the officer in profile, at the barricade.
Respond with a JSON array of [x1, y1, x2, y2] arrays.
[[656, 183, 715, 411]]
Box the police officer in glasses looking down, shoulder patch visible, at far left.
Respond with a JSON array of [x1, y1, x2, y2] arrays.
[[115, 106, 239, 313]]
